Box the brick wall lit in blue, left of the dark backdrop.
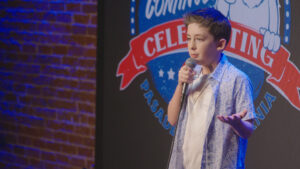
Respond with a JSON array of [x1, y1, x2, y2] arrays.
[[0, 0, 97, 169]]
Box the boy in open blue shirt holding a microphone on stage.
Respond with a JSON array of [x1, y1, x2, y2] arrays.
[[168, 8, 255, 169]]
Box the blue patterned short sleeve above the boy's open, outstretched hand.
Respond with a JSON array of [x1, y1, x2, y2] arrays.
[[235, 75, 256, 120]]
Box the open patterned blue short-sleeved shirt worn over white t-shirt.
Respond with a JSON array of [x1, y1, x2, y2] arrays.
[[169, 54, 256, 169]]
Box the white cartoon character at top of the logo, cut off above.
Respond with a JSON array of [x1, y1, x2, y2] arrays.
[[216, 0, 280, 52]]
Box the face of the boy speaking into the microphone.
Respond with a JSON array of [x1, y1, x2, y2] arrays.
[[187, 23, 221, 65]]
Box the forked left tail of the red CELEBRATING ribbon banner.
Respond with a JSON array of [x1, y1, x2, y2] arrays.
[[116, 50, 147, 90]]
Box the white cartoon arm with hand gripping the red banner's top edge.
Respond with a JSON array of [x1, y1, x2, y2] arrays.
[[259, 0, 280, 52]]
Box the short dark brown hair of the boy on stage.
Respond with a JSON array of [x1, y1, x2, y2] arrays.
[[183, 8, 231, 45]]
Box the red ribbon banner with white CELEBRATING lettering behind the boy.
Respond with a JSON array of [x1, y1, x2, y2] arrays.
[[117, 19, 300, 110]]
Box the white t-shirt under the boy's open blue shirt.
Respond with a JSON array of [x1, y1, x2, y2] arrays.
[[182, 66, 213, 169]]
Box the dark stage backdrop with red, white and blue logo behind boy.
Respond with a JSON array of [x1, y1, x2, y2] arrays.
[[96, 0, 300, 169]]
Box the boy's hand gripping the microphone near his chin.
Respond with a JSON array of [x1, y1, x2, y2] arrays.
[[178, 65, 196, 84]]
